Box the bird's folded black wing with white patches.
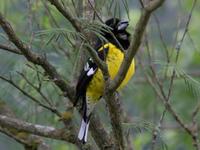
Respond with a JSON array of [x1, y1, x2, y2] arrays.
[[74, 47, 109, 105]]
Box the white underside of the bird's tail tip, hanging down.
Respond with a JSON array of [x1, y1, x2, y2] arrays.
[[78, 117, 90, 143]]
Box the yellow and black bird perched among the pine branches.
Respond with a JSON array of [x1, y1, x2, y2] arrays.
[[74, 18, 135, 143]]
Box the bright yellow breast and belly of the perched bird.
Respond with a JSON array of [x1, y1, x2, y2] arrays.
[[86, 43, 135, 102]]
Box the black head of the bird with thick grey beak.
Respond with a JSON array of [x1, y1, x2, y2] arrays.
[[96, 18, 130, 50]]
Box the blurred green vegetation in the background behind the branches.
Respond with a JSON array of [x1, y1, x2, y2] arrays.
[[0, 0, 200, 150]]
